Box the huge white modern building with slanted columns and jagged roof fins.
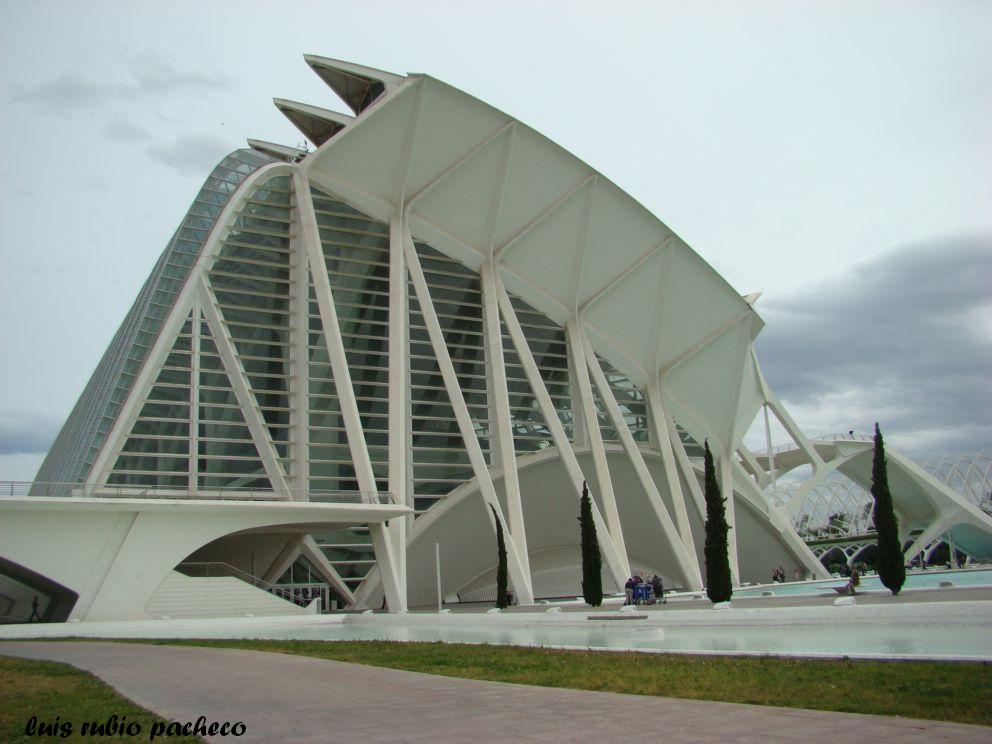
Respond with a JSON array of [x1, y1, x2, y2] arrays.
[[0, 56, 992, 619]]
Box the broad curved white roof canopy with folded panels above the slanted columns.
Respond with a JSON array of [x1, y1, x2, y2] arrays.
[[305, 58, 762, 449]]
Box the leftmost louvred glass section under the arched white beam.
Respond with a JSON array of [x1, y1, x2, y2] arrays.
[[108, 176, 290, 490]]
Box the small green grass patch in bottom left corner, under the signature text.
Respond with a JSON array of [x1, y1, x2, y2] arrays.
[[0, 656, 203, 742]]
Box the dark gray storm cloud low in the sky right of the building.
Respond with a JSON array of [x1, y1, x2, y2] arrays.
[[756, 236, 992, 454]]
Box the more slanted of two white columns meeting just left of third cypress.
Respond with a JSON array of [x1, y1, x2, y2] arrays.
[[585, 343, 703, 591]]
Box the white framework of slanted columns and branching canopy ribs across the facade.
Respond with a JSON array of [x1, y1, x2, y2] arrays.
[[52, 57, 992, 611]]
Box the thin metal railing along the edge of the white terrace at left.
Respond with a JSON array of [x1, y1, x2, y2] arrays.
[[0, 481, 395, 504]]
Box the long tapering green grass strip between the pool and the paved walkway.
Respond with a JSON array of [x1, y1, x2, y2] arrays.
[[141, 640, 992, 726]]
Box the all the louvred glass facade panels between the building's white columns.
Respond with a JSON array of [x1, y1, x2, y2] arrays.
[[43, 151, 649, 590]]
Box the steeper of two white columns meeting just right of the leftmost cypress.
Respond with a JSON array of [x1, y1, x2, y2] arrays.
[[481, 263, 534, 604]]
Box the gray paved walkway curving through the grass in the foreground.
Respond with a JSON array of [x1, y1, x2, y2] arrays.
[[0, 643, 992, 744]]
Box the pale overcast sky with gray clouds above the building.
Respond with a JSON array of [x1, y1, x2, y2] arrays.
[[0, 0, 992, 480]]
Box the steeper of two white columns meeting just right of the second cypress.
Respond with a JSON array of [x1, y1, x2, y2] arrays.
[[565, 316, 630, 575]]
